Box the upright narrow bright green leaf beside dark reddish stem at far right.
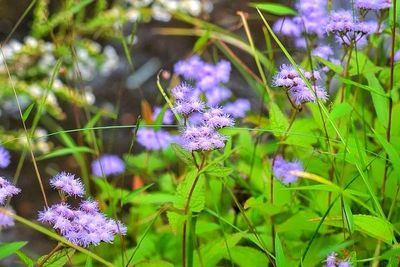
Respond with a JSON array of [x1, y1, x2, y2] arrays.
[[364, 73, 389, 127]]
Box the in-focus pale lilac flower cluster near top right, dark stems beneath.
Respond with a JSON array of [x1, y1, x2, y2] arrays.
[[325, 10, 371, 45]]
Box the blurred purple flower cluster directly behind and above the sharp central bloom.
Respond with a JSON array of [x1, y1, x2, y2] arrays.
[[174, 55, 250, 118]]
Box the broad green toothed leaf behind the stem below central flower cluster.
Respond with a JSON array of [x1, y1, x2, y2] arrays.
[[174, 170, 206, 212]]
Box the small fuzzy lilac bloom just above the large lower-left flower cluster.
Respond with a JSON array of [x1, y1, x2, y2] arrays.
[[50, 172, 85, 197]]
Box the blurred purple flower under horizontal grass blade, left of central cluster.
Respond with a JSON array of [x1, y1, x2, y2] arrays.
[[136, 128, 174, 150]]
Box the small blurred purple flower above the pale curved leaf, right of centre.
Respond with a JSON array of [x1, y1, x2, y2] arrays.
[[272, 156, 304, 185]]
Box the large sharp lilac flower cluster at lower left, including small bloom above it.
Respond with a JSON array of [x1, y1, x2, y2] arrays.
[[38, 172, 127, 247]]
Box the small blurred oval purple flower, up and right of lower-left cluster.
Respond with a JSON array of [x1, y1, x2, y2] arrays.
[[92, 154, 125, 177]]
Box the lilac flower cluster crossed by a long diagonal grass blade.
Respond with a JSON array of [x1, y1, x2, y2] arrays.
[[273, 64, 328, 105]]
